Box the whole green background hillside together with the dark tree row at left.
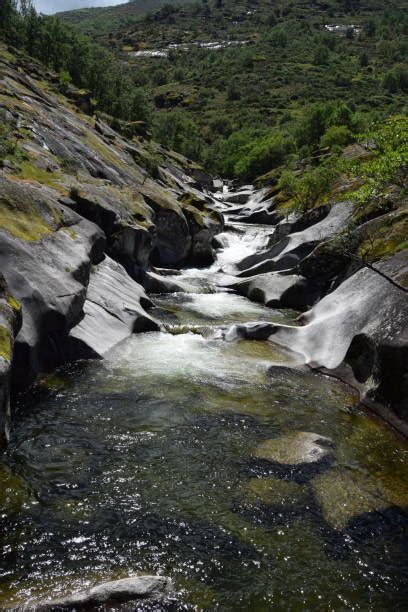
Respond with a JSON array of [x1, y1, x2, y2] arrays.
[[0, 0, 408, 184]]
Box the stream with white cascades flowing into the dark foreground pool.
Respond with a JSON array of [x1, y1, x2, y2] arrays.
[[0, 189, 408, 612]]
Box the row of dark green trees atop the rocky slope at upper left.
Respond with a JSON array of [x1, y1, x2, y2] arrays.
[[0, 0, 149, 121]]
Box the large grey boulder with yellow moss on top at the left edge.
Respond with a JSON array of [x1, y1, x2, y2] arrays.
[[0, 176, 105, 384]]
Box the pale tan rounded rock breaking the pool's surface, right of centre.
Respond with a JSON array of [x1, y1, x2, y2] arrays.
[[254, 431, 332, 466]]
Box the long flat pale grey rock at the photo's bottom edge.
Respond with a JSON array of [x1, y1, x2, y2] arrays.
[[37, 576, 173, 611]]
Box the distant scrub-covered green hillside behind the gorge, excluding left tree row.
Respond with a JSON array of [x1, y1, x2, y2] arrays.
[[61, 0, 408, 180]]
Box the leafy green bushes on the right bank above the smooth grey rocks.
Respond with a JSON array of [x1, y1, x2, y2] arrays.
[[274, 115, 408, 263]]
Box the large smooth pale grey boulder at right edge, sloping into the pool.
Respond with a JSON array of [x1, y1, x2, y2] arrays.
[[226, 250, 408, 431]]
